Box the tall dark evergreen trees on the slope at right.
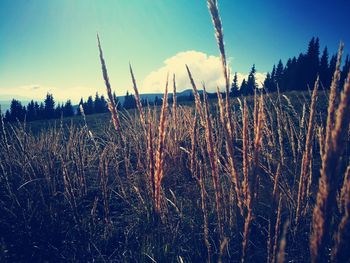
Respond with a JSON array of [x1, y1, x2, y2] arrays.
[[231, 37, 350, 96]]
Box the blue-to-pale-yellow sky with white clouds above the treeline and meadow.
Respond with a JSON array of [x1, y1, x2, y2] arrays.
[[0, 0, 350, 103]]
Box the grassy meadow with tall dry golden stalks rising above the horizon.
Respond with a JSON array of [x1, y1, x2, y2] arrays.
[[0, 0, 350, 262]]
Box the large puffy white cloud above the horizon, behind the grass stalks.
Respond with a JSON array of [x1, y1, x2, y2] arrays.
[[141, 50, 266, 93]]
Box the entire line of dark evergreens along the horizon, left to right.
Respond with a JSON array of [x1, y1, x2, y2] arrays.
[[1, 37, 350, 122]]
